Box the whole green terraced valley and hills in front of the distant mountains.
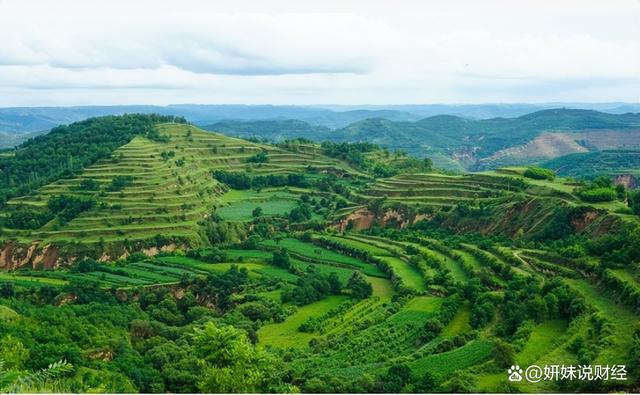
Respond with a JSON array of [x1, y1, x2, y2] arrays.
[[0, 115, 640, 393]]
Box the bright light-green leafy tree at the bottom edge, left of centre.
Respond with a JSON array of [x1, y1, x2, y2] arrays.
[[193, 322, 279, 393]]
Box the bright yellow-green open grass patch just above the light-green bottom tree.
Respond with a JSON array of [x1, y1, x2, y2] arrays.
[[258, 296, 347, 348]]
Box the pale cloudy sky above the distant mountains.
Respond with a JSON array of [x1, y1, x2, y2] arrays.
[[0, 0, 640, 107]]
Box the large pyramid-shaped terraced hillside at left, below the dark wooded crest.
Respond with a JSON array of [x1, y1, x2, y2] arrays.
[[3, 124, 353, 262]]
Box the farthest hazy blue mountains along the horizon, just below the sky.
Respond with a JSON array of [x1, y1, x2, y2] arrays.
[[0, 103, 640, 133]]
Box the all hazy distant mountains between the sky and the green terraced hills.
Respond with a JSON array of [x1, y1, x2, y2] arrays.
[[0, 103, 640, 174]]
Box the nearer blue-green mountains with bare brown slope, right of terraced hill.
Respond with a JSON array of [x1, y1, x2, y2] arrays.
[[206, 109, 640, 170]]
